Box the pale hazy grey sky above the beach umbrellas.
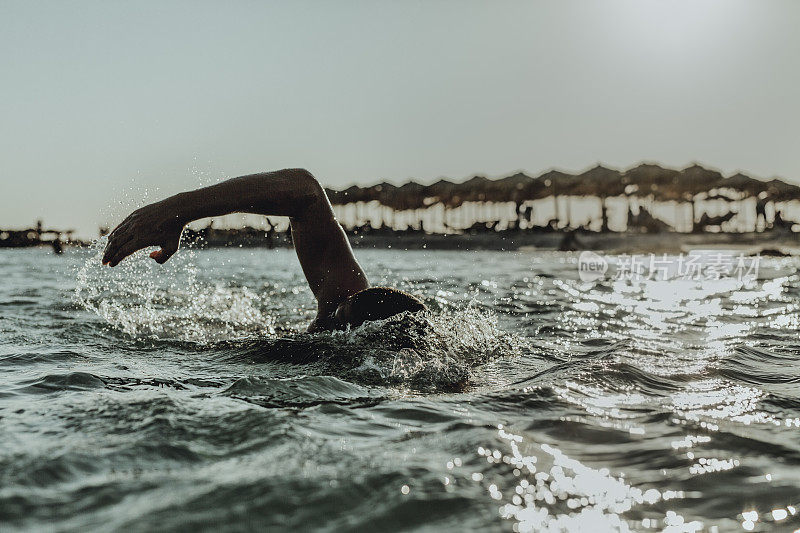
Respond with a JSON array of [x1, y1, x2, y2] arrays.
[[0, 0, 800, 236]]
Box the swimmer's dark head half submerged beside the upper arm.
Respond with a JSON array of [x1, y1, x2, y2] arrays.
[[334, 287, 426, 328]]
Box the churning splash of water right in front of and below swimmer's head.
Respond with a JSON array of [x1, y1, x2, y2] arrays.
[[225, 307, 526, 392]]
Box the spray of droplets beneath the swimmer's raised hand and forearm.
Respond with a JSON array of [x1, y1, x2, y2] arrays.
[[75, 237, 275, 344]]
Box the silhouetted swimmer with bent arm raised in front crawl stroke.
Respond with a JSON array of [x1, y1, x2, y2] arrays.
[[103, 169, 425, 332]]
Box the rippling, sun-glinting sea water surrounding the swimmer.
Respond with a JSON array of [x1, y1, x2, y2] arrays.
[[0, 243, 800, 531]]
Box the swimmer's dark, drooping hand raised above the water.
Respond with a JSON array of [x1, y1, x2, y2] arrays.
[[103, 198, 186, 267]]
